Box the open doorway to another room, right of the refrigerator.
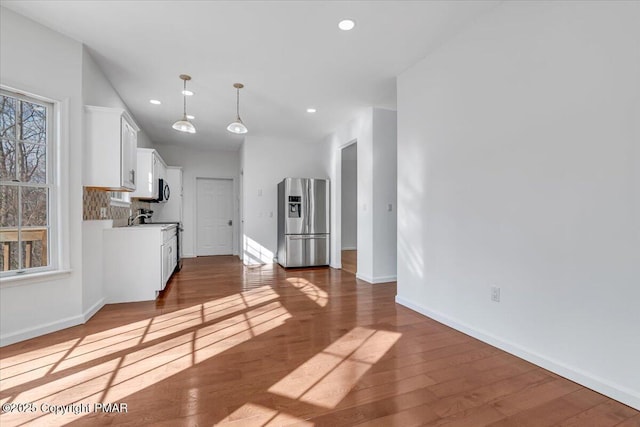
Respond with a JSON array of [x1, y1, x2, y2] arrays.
[[340, 142, 358, 274]]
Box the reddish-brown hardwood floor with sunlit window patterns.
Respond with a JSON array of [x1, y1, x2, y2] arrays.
[[0, 256, 640, 427]]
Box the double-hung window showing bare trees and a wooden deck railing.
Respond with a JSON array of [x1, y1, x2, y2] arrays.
[[0, 90, 56, 276]]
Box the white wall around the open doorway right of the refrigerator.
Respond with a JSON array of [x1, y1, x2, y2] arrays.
[[324, 108, 397, 283]]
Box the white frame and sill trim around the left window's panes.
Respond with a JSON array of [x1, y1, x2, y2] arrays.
[[0, 85, 58, 282]]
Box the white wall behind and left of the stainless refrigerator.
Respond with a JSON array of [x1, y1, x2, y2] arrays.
[[242, 136, 335, 264]]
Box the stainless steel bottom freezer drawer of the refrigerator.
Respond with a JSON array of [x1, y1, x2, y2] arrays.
[[280, 234, 329, 267]]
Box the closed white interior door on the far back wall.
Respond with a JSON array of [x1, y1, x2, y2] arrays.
[[196, 178, 233, 256]]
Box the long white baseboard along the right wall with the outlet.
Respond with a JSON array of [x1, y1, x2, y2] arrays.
[[396, 296, 640, 410]]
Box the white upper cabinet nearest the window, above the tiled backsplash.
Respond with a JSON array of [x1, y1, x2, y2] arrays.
[[83, 105, 140, 191]]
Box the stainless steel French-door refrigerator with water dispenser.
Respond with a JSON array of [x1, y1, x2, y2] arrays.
[[278, 178, 330, 267]]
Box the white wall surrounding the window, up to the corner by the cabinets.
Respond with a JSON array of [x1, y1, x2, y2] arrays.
[[0, 8, 84, 345]]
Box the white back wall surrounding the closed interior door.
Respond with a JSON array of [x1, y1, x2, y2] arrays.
[[151, 145, 240, 257]]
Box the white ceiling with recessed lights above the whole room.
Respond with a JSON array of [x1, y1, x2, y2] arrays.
[[1, 0, 499, 150]]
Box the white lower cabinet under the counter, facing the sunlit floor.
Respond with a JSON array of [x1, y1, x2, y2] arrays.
[[104, 224, 177, 303]]
